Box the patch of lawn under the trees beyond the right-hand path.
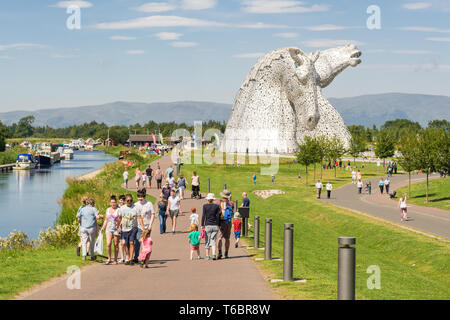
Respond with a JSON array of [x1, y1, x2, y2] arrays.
[[396, 177, 450, 210]]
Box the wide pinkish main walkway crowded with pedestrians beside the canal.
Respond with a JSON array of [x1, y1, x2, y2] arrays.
[[19, 156, 277, 300]]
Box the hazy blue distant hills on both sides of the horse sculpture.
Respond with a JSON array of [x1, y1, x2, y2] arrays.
[[0, 93, 450, 128]]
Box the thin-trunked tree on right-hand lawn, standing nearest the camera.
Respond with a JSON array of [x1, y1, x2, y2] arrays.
[[416, 128, 442, 202]]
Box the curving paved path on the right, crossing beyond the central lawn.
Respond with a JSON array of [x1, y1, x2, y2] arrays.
[[322, 174, 450, 238]]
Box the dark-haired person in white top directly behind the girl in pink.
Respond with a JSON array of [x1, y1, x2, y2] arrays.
[[134, 188, 155, 263]]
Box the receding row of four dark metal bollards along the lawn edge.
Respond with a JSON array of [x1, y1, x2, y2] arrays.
[[253, 216, 356, 300]]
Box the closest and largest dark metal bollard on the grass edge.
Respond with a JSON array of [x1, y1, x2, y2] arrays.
[[338, 237, 356, 300]]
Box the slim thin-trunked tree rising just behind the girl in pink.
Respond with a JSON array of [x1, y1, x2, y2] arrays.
[[397, 131, 418, 197]]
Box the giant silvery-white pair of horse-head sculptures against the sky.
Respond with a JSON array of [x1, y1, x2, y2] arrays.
[[221, 45, 361, 153]]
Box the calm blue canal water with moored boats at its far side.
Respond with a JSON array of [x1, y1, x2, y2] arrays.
[[0, 151, 117, 239]]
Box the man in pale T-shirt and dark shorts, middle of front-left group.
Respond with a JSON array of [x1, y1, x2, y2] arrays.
[[117, 194, 138, 265]]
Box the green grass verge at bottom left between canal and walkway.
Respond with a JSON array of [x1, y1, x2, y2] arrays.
[[0, 248, 92, 300]]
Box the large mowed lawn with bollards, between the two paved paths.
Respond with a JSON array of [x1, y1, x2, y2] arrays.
[[182, 163, 450, 299]]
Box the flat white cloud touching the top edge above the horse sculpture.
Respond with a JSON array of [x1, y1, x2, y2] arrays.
[[241, 0, 330, 14]]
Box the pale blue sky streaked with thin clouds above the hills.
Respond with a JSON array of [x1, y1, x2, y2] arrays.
[[0, 0, 450, 112]]
